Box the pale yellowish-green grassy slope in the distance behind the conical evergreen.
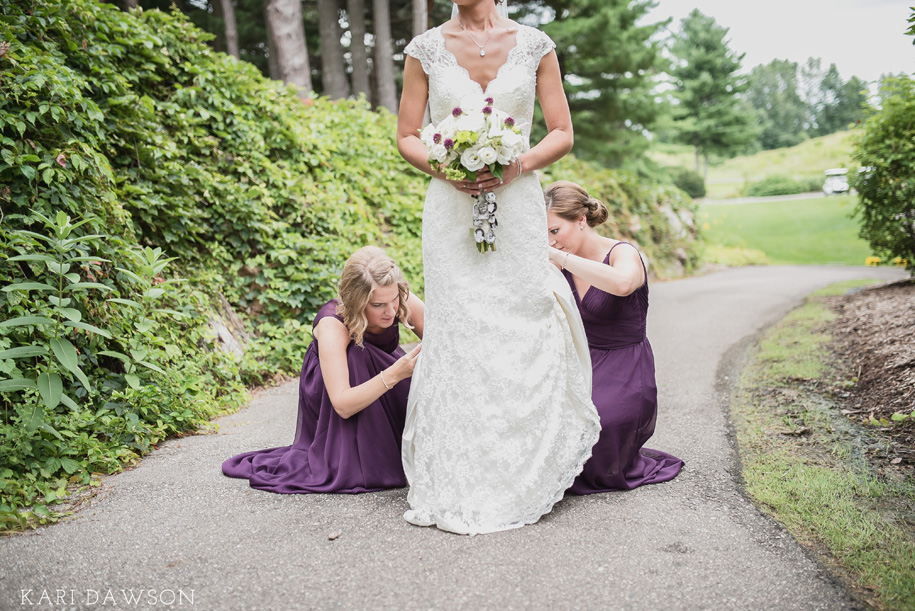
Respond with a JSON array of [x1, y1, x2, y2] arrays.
[[649, 131, 855, 199]]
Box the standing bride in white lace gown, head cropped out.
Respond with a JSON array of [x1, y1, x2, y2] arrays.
[[397, 0, 600, 534]]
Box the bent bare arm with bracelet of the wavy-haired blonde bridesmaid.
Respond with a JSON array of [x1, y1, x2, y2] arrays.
[[314, 316, 419, 418]]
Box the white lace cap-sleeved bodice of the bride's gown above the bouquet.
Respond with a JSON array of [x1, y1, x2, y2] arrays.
[[404, 24, 556, 142]]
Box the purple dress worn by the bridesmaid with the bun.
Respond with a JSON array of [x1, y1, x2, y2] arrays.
[[562, 242, 683, 494]]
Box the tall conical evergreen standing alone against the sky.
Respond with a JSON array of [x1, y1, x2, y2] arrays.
[[671, 9, 758, 175]]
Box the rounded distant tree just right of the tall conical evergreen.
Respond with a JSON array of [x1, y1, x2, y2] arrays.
[[746, 59, 807, 149]]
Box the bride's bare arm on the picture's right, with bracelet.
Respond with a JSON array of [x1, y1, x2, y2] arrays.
[[521, 51, 575, 172]]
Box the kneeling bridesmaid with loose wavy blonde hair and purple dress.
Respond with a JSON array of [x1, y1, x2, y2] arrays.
[[222, 246, 423, 494]]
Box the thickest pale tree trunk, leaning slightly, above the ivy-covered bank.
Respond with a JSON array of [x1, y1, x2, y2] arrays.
[[266, 0, 312, 98]]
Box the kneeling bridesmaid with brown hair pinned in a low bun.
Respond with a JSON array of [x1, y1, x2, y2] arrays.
[[544, 181, 683, 494]]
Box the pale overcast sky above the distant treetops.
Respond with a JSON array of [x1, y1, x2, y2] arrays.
[[648, 0, 915, 81]]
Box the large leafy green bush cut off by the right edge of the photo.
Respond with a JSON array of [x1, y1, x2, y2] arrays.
[[851, 76, 915, 272]]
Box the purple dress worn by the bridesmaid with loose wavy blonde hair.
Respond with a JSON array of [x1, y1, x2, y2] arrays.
[[222, 299, 410, 494]]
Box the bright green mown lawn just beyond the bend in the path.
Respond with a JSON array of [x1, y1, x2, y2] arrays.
[[698, 195, 872, 265]]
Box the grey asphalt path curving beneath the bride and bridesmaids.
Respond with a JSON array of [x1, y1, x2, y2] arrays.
[[0, 267, 902, 610]]
